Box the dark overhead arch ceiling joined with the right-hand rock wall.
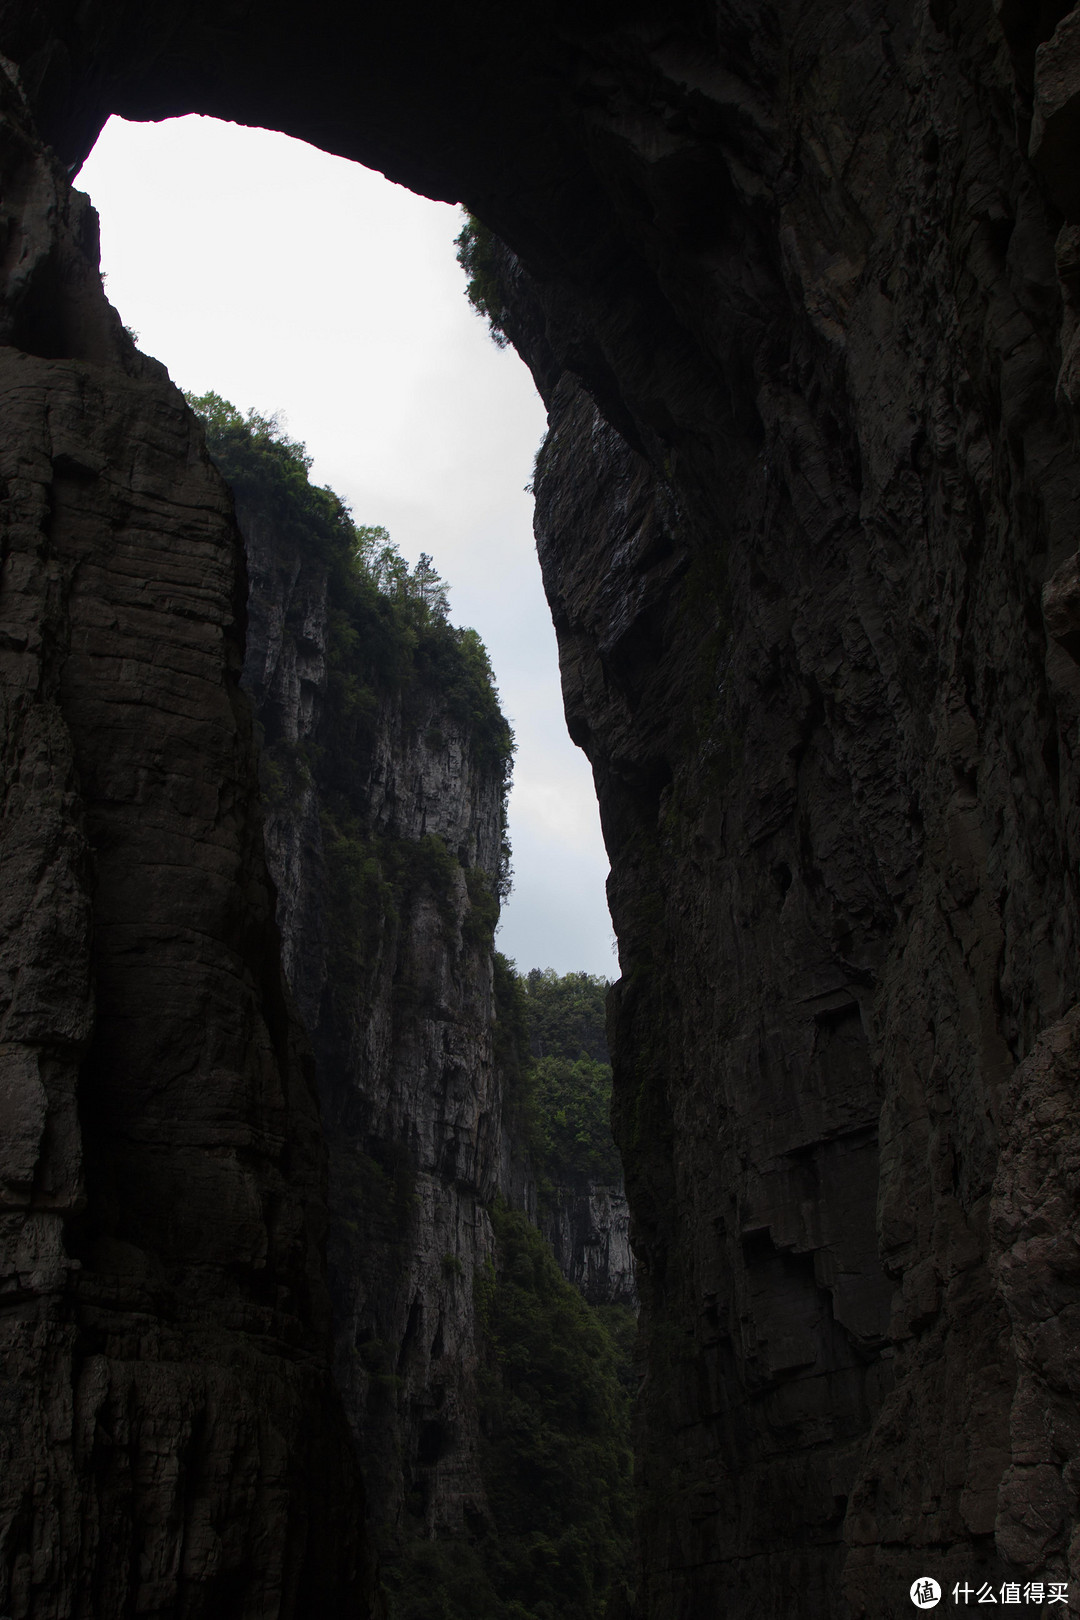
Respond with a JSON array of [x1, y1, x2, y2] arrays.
[[0, 0, 1080, 1620]]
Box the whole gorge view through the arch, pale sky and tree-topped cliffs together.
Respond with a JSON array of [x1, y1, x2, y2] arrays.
[[76, 117, 636, 1620]]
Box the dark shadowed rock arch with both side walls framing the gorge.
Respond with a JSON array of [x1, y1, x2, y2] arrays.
[[0, 0, 1080, 1620]]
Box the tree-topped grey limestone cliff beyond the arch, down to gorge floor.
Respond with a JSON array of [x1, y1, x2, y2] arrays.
[[207, 395, 633, 1620]]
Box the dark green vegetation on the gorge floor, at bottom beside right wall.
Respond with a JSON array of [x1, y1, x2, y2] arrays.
[[387, 1202, 633, 1620]]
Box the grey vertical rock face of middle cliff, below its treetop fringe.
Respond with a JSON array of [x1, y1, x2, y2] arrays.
[[238, 473, 524, 1547]]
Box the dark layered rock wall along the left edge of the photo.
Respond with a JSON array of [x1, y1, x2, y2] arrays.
[[0, 53, 371, 1620]]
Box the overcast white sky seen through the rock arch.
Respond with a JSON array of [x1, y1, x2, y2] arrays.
[[76, 118, 617, 978]]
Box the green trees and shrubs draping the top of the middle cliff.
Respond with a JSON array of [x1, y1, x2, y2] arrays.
[[188, 392, 513, 1019]]
